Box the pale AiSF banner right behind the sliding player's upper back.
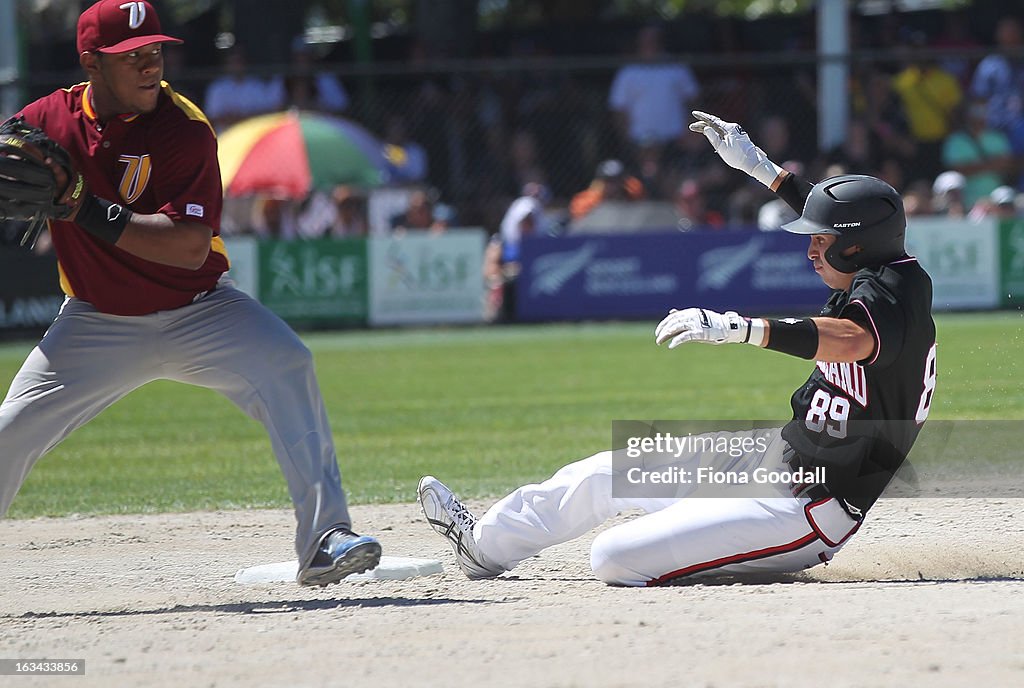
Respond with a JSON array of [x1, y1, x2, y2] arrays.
[[906, 217, 999, 310]]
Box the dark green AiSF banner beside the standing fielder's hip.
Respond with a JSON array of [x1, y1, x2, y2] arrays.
[[258, 239, 369, 325]]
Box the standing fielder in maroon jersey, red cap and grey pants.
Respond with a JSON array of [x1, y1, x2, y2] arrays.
[[0, 0, 381, 586]]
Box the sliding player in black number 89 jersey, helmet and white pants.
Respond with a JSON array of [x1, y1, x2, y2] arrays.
[[419, 112, 936, 586]]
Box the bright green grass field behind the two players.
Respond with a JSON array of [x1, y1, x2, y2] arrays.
[[0, 313, 1024, 517]]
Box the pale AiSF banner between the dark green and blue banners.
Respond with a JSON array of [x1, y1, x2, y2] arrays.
[[368, 228, 484, 326]]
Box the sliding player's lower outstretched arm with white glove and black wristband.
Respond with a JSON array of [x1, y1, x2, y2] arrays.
[[654, 308, 876, 362]]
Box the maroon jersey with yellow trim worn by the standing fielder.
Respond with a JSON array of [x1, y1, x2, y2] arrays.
[[22, 82, 228, 315]]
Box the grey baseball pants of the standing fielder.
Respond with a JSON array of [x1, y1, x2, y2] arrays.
[[0, 278, 350, 567]]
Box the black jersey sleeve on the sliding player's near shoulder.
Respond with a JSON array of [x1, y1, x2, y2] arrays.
[[839, 267, 906, 369]]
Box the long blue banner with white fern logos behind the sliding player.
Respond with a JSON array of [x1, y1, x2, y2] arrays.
[[516, 231, 829, 320]]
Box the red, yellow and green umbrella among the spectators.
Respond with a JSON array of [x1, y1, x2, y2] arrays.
[[217, 111, 390, 199]]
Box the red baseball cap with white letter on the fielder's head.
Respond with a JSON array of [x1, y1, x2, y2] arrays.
[[78, 0, 182, 54]]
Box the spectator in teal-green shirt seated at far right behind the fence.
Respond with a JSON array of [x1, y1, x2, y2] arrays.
[[942, 100, 1014, 208]]
